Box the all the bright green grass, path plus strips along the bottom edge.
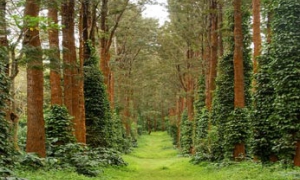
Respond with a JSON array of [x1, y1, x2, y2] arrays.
[[20, 132, 300, 180]]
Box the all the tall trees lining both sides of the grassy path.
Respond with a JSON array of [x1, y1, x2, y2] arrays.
[[0, 0, 300, 171]]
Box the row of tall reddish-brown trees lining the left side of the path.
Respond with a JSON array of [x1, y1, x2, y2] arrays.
[[0, 0, 162, 165]]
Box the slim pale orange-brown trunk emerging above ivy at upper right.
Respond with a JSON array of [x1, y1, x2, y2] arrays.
[[252, 0, 261, 74]]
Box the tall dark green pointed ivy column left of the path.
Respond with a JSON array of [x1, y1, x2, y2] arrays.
[[84, 50, 113, 147]]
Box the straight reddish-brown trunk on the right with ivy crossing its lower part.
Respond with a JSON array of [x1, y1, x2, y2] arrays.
[[233, 0, 245, 158]]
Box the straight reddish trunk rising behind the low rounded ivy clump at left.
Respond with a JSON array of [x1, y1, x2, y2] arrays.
[[48, 0, 62, 105]]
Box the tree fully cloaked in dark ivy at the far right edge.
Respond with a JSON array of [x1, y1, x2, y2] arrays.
[[271, 0, 300, 166]]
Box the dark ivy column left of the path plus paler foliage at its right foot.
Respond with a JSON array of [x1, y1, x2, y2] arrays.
[[84, 48, 130, 151]]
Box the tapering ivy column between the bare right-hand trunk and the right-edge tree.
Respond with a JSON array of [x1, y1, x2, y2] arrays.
[[251, 50, 279, 163]]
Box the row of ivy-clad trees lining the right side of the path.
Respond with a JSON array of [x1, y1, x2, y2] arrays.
[[165, 0, 299, 166]]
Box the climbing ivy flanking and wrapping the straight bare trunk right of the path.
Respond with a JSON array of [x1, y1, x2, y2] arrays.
[[211, 4, 252, 159]]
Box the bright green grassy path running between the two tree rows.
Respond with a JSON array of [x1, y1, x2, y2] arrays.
[[104, 132, 201, 180]]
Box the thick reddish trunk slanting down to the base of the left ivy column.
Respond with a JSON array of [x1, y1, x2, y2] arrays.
[[62, 0, 85, 143]]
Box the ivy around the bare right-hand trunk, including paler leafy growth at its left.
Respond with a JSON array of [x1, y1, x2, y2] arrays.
[[195, 4, 252, 161]]
